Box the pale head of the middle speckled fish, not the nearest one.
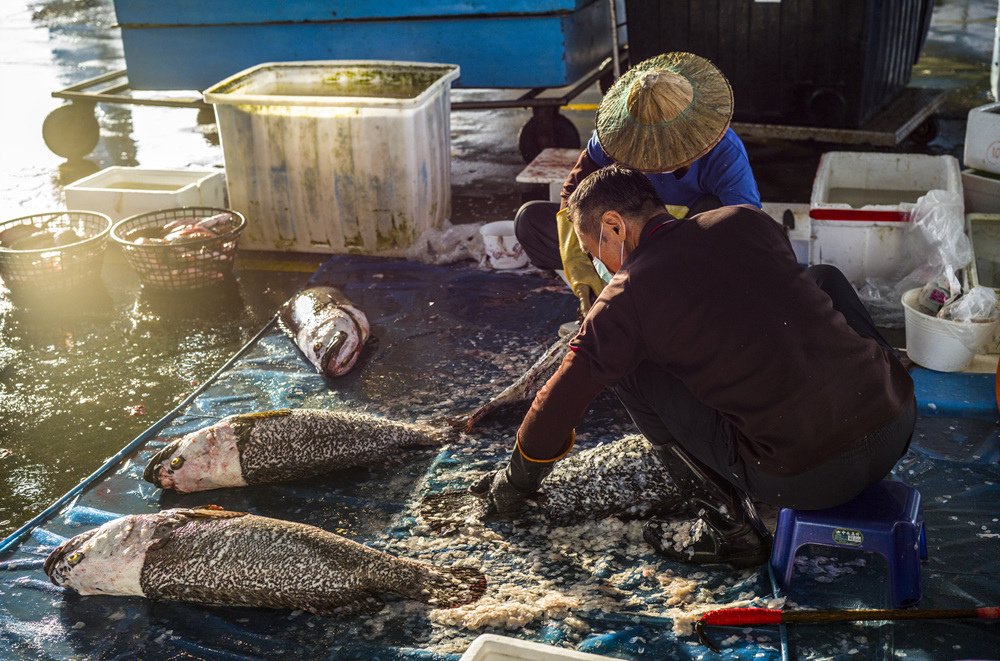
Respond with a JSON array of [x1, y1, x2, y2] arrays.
[[143, 421, 247, 493]]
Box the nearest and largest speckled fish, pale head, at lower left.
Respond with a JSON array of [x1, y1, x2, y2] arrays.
[[45, 506, 486, 615]]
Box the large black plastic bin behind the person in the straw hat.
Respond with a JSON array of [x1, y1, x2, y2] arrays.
[[625, 0, 934, 128]]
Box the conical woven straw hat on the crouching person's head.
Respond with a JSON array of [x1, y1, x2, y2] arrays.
[[597, 53, 733, 172]]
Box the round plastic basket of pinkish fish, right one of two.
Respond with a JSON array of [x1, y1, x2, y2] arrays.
[[111, 207, 246, 290]]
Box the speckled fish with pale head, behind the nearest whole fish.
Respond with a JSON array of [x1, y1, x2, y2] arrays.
[[143, 409, 451, 493]]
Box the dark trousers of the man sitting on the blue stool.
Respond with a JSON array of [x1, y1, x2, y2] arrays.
[[615, 265, 916, 509]]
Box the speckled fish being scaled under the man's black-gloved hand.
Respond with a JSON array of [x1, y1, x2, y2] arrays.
[[419, 434, 684, 531]]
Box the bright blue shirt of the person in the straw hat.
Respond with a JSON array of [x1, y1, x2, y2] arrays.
[[587, 129, 760, 209]]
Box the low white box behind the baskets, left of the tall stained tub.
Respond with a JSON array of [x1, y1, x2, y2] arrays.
[[63, 166, 226, 220]]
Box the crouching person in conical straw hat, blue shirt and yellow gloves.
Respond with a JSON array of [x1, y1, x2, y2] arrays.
[[514, 53, 760, 315]]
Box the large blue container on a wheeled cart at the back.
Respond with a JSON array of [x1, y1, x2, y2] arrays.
[[115, 0, 611, 89]]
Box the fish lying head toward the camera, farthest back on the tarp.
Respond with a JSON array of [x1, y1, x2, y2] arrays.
[[278, 287, 370, 377]]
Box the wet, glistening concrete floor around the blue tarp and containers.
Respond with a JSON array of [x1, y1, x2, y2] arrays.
[[0, 0, 996, 537]]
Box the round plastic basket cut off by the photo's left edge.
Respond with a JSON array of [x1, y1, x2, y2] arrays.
[[0, 211, 112, 294]]
